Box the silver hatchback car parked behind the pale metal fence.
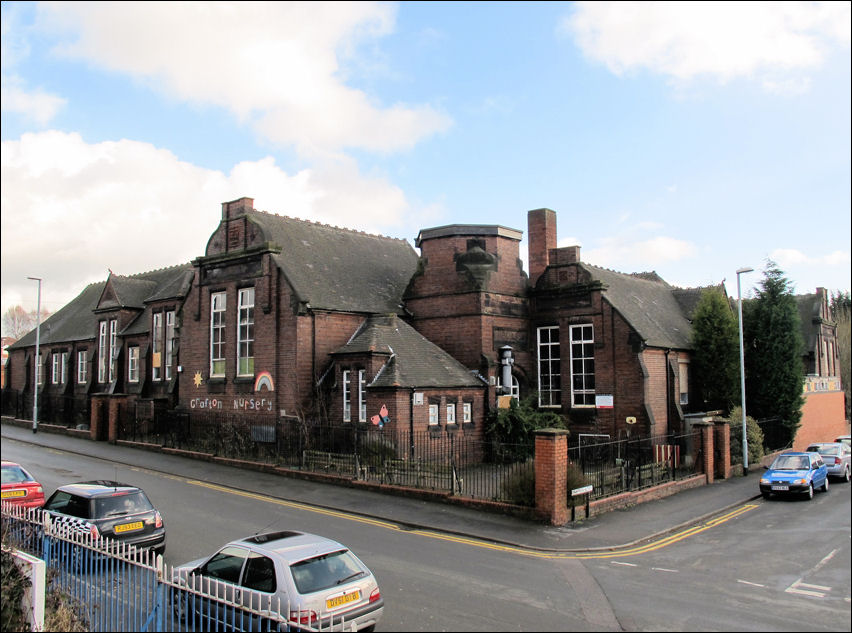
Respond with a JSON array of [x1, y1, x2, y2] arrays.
[[173, 531, 384, 631]]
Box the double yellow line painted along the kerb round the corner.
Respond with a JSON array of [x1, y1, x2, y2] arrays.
[[184, 479, 758, 559]]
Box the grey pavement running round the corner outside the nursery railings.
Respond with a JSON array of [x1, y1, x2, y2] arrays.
[[2, 420, 763, 552]]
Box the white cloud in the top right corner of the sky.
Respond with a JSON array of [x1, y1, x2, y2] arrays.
[[560, 2, 850, 85]]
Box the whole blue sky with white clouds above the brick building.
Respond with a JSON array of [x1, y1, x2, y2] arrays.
[[0, 2, 852, 330]]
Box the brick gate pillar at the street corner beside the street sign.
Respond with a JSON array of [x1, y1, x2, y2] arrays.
[[535, 429, 569, 525]]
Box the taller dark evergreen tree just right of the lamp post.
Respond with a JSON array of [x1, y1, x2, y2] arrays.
[[743, 260, 804, 447]]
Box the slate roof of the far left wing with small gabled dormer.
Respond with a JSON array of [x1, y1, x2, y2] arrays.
[[10, 264, 193, 349]]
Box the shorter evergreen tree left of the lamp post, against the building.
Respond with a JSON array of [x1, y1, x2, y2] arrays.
[[692, 288, 740, 413]]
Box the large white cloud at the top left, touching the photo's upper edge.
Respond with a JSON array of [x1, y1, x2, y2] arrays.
[[40, 2, 451, 155]]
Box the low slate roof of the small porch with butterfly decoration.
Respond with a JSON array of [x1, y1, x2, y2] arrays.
[[335, 314, 485, 389]]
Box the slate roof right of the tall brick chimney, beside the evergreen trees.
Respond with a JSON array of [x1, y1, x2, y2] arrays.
[[578, 262, 701, 349]]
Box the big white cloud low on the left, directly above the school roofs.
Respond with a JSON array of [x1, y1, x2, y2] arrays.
[[0, 131, 426, 320]]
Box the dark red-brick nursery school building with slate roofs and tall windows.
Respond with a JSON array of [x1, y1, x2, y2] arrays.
[[8, 198, 804, 446]]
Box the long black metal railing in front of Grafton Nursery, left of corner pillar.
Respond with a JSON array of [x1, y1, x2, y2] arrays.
[[111, 407, 533, 503]]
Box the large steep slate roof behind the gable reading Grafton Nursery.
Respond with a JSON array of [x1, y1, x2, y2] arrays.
[[246, 210, 418, 313]]
